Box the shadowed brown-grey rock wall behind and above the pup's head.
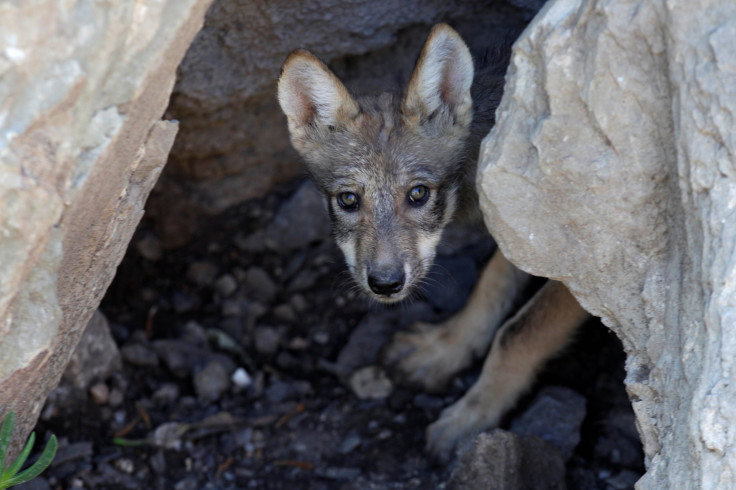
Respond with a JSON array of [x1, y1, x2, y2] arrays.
[[150, 0, 540, 246]]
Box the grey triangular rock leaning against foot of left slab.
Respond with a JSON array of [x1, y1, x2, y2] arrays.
[[63, 310, 122, 392]]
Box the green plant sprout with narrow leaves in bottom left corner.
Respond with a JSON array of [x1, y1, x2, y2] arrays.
[[0, 412, 59, 490]]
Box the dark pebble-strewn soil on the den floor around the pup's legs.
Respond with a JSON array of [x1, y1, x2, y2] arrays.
[[25, 178, 643, 490]]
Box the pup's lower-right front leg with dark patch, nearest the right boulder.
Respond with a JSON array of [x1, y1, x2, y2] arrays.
[[427, 281, 589, 461]]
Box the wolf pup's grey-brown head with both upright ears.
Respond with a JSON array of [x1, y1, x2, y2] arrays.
[[278, 24, 473, 303]]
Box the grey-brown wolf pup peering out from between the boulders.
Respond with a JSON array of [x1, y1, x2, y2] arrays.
[[278, 24, 588, 461]]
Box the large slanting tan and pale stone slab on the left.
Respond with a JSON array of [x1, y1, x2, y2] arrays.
[[0, 0, 209, 454]]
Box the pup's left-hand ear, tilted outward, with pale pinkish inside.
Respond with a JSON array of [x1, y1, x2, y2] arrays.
[[278, 50, 359, 132]]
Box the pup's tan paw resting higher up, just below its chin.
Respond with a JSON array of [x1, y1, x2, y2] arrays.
[[381, 323, 473, 393]]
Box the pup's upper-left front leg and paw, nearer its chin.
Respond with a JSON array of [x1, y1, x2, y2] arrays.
[[383, 251, 529, 391]]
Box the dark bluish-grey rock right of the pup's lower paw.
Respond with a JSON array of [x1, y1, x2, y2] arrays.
[[509, 386, 585, 459]]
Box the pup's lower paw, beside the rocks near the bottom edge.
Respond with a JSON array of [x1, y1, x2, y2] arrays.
[[426, 393, 501, 464]]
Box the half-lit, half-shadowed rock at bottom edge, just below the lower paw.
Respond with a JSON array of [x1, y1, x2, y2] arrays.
[[447, 429, 565, 490]]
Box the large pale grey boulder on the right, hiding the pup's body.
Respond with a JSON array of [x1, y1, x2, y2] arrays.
[[480, 0, 736, 489]]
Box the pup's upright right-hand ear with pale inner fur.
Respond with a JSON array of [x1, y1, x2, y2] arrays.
[[402, 24, 474, 125]]
